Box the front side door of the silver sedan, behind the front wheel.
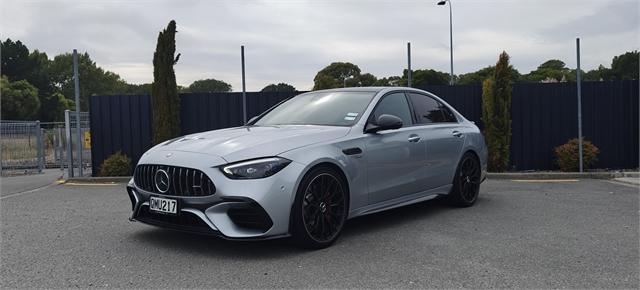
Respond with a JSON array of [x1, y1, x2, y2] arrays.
[[365, 92, 426, 204]]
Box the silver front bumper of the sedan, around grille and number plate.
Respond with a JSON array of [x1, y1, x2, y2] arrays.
[[127, 154, 304, 239]]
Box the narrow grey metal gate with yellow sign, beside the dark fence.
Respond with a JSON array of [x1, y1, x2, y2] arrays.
[[64, 110, 91, 177]]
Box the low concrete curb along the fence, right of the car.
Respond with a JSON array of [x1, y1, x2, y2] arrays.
[[487, 172, 640, 180]]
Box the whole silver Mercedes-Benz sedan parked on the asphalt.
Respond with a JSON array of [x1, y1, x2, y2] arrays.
[[127, 87, 487, 248]]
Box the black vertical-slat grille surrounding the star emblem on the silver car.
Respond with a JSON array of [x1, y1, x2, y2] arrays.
[[133, 164, 216, 196]]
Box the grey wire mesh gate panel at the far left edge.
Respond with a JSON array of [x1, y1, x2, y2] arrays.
[[0, 121, 44, 175]]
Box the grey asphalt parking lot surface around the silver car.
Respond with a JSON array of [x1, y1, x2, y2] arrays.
[[0, 180, 640, 289]]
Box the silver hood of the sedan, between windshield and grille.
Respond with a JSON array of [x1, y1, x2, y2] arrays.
[[154, 125, 350, 162]]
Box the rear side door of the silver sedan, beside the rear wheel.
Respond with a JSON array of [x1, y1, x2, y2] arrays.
[[408, 93, 465, 189]]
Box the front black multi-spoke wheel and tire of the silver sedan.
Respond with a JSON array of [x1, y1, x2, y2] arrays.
[[290, 167, 349, 249]]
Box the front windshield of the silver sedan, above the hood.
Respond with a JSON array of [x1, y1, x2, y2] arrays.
[[255, 92, 375, 126]]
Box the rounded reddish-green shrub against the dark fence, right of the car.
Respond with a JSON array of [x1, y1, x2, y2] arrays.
[[554, 138, 600, 171]]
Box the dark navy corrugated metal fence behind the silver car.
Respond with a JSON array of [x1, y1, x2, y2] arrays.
[[90, 80, 639, 175]]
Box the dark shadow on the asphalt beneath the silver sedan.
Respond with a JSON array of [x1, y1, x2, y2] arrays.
[[132, 195, 468, 260]]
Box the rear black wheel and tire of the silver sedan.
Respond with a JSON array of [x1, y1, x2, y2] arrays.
[[447, 152, 482, 207]]
